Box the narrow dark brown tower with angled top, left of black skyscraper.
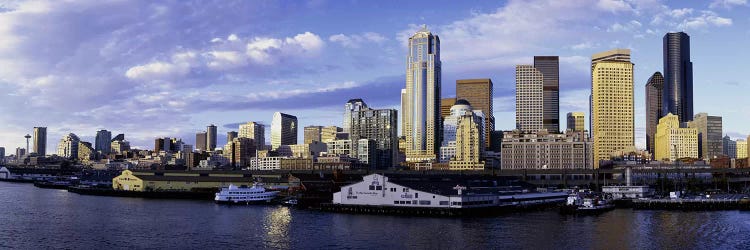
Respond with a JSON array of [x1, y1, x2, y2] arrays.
[[646, 71, 664, 156]]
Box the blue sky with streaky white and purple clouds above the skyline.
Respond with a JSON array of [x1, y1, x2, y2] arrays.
[[0, 0, 750, 154]]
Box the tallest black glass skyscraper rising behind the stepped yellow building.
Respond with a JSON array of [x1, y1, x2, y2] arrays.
[[662, 32, 693, 123]]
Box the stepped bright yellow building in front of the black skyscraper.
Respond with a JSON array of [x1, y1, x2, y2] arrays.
[[654, 113, 698, 161]]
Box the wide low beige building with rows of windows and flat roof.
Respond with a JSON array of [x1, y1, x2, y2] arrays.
[[500, 130, 594, 169]]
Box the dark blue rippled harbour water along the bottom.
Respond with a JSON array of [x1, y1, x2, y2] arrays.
[[0, 182, 750, 249]]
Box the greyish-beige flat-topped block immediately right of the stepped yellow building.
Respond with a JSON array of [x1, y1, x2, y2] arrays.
[[687, 113, 724, 160]]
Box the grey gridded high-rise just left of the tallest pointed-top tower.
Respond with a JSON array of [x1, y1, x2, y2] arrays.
[[349, 108, 398, 169]]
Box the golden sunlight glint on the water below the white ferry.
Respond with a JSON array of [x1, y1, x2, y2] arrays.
[[263, 206, 292, 249]]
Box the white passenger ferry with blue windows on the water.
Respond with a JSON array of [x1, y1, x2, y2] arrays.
[[214, 183, 279, 204]]
